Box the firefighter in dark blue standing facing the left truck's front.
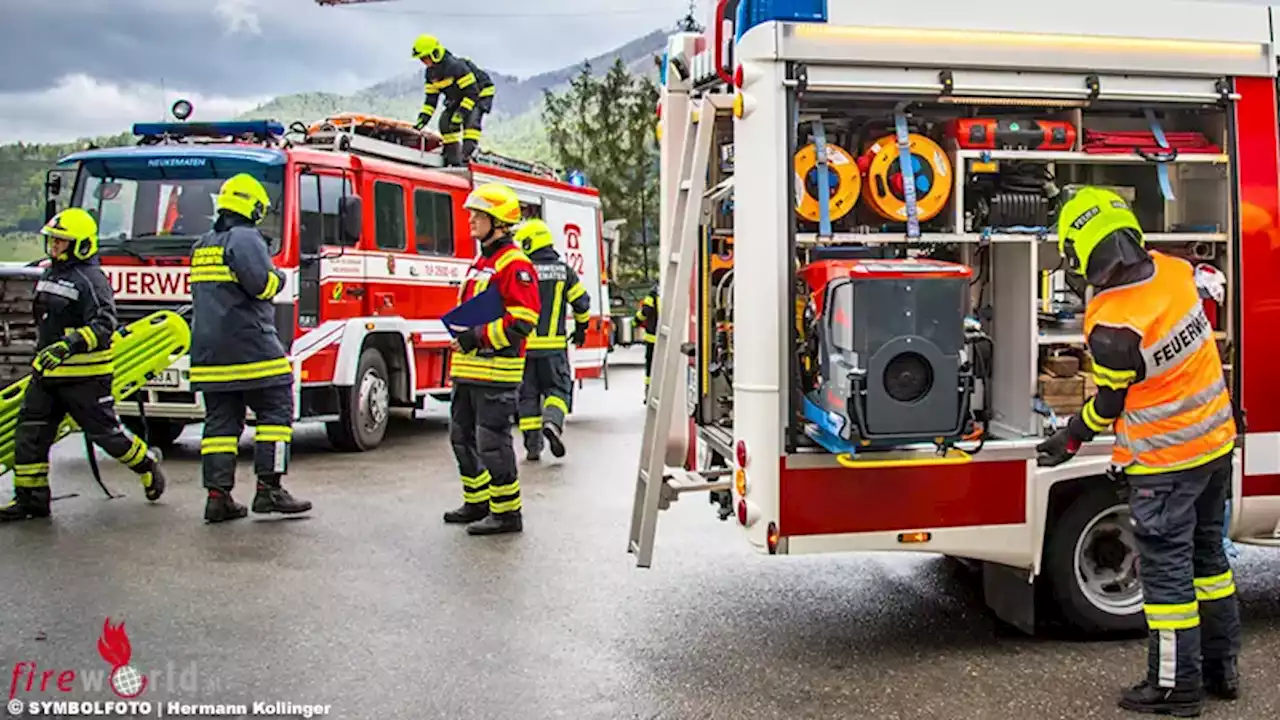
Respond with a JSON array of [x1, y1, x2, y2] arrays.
[[191, 174, 311, 523]]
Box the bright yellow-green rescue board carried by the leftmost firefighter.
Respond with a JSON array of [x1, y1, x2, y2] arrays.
[[0, 310, 191, 473]]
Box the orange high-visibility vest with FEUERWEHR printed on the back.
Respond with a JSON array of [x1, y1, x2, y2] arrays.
[[1084, 252, 1236, 474]]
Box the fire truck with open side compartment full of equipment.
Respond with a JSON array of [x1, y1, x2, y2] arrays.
[[630, 0, 1280, 632]]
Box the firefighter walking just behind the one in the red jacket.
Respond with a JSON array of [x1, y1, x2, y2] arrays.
[[516, 219, 591, 460]]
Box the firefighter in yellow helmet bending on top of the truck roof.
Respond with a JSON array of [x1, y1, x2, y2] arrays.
[[413, 35, 495, 167]]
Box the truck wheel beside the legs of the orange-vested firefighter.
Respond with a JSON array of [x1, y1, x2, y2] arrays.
[[1043, 480, 1146, 634]]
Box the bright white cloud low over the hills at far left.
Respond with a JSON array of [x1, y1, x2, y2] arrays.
[[0, 73, 265, 143]]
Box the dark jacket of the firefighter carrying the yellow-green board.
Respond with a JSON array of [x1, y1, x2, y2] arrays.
[[32, 256, 116, 380]]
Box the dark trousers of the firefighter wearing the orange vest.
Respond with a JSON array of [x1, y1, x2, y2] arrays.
[[1126, 455, 1240, 689]]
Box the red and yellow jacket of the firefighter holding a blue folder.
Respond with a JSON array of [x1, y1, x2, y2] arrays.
[[449, 238, 540, 388]]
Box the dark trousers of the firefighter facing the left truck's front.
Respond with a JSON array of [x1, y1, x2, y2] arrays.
[[200, 384, 293, 492]]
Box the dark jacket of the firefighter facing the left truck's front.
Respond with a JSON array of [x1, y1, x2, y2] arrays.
[[191, 214, 293, 392]]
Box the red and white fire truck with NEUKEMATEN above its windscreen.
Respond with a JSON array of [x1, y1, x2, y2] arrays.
[[49, 117, 611, 451]]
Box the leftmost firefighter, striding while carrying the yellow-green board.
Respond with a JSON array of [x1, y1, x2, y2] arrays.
[[0, 208, 165, 521]]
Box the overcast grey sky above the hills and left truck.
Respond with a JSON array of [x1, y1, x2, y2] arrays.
[[0, 0, 705, 143]]
